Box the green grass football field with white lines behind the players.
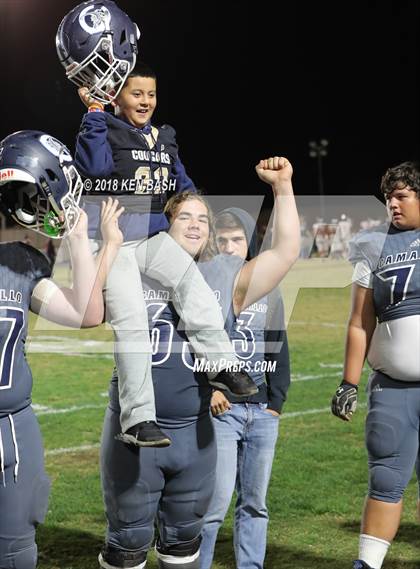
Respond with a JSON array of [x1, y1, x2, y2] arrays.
[[29, 265, 420, 569]]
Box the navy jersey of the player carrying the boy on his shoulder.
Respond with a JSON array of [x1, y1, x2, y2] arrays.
[[110, 255, 242, 428]]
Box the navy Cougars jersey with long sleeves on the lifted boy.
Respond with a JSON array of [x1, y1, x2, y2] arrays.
[[75, 112, 195, 241]]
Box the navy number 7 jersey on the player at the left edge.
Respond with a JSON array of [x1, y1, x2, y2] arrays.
[[0, 242, 51, 417]]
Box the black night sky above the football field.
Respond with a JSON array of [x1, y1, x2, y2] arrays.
[[0, 0, 420, 202]]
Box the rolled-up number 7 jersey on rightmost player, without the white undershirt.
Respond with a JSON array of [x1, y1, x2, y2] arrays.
[[350, 224, 420, 322]]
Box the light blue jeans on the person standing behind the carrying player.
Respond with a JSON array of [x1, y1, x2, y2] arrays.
[[200, 403, 279, 569]]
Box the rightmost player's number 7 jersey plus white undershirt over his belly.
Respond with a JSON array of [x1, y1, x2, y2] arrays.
[[350, 225, 420, 381]]
